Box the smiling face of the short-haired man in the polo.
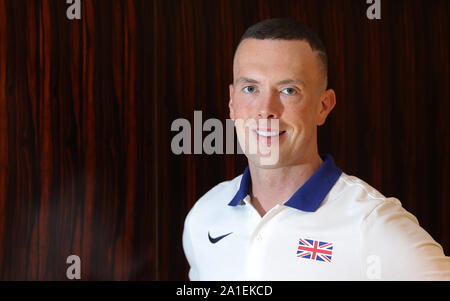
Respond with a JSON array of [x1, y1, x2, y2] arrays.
[[229, 39, 335, 168]]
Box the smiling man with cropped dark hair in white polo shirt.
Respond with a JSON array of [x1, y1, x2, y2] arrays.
[[183, 19, 450, 280]]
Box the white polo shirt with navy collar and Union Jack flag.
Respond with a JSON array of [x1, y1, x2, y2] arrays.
[[183, 155, 450, 280]]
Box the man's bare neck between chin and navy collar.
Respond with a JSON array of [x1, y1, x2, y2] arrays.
[[249, 154, 323, 216]]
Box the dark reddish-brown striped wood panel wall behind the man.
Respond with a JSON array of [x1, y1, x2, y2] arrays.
[[0, 0, 450, 280]]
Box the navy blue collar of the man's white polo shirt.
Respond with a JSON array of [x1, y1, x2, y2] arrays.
[[228, 154, 342, 212]]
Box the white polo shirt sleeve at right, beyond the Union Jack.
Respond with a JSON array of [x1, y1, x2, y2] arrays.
[[360, 198, 450, 280]]
